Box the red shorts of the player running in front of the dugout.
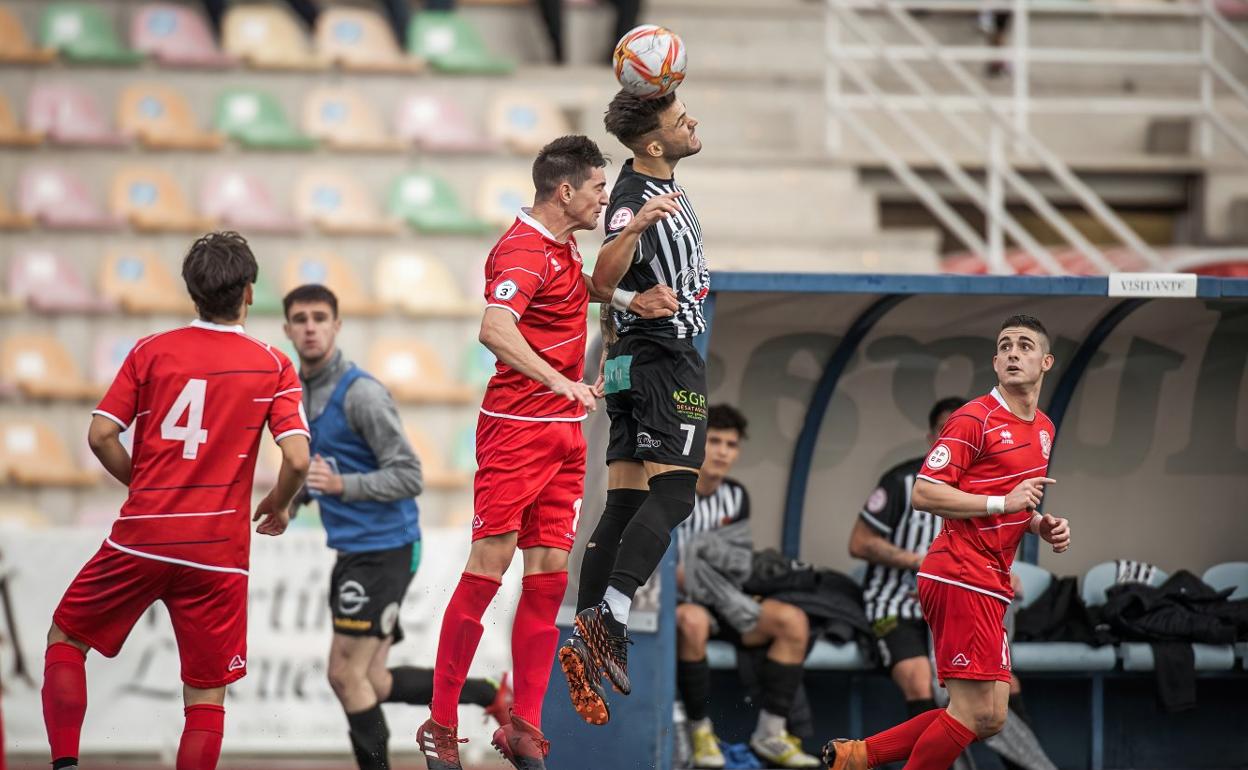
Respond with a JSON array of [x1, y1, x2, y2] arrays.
[[919, 575, 1010, 683]]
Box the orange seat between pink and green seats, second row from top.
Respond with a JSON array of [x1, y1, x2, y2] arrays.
[[117, 84, 226, 151]]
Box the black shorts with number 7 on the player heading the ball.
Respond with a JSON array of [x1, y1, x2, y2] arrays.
[[604, 334, 706, 470]]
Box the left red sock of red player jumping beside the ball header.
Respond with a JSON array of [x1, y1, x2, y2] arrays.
[[429, 572, 502, 728]]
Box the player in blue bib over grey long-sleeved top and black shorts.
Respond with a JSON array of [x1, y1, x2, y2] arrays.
[[282, 285, 510, 770]]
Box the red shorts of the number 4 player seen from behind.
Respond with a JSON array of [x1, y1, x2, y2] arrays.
[[52, 543, 247, 689]]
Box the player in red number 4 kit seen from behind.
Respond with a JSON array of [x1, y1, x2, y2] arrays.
[[44, 232, 310, 770]]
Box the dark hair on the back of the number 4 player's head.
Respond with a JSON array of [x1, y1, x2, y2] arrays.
[[182, 230, 260, 321]]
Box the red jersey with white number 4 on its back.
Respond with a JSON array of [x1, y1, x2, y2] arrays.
[[92, 321, 311, 572]]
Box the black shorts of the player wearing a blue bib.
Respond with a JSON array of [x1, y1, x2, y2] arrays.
[[329, 540, 421, 644]]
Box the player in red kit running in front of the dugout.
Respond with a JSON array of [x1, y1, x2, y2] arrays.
[[824, 316, 1071, 770]]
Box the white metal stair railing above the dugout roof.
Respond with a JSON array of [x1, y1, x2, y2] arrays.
[[825, 0, 1248, 275]]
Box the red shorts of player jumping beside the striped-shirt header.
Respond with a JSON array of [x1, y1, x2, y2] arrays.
[[472, 414, 585, 550]]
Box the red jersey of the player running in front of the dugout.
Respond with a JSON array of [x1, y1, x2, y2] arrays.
[[919, 388, 1055, 602]]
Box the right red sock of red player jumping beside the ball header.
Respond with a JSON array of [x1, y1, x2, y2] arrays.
[[512, 572, 568, 730]]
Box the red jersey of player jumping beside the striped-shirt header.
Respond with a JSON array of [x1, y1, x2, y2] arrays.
[[480, 210, 589, 422]]
